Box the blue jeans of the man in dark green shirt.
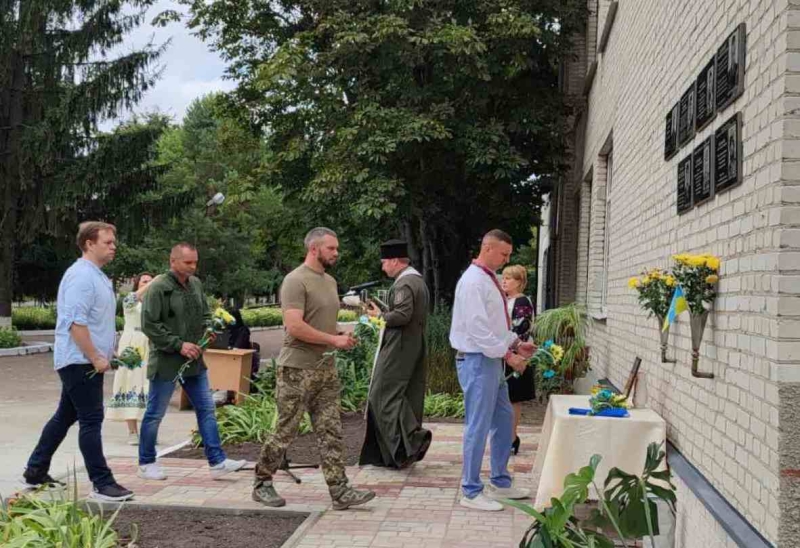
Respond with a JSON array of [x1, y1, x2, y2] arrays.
[[139, 371, 226, 466]]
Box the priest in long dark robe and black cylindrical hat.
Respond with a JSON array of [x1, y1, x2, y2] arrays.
[[359, 240, 432, 468]]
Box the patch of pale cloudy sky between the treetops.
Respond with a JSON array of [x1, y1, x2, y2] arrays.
[[101, 0, 234, 131]]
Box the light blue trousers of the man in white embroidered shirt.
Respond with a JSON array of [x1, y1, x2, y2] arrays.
[[456, 354, 514, 499]]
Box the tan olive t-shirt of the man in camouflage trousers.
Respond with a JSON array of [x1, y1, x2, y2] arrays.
[[278, 265, 339, 369]]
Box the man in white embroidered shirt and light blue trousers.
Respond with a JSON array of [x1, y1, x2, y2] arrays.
[[450, 230, 534, 511]]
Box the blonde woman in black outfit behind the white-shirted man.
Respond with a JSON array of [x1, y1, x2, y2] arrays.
[[503, 265, 535, 455]]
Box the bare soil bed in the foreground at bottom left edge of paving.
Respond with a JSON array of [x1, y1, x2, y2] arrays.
[[113, 506, 305, 548]]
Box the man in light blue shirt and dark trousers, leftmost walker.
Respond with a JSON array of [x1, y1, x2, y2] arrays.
[[23, 221, 133, 501]]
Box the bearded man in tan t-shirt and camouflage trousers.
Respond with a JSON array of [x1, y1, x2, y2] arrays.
[[252, 228, 375, 510]]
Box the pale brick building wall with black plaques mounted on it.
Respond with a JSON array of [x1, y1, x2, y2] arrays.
[[573, 0, 788, 548]]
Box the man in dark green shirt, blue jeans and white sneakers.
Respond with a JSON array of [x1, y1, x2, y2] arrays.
[[137, 243, 246, 480]]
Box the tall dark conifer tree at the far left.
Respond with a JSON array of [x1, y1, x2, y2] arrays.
[[0, 0, 163, 322]]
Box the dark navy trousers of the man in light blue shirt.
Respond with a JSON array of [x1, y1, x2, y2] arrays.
[[28, 363, 115, 489]]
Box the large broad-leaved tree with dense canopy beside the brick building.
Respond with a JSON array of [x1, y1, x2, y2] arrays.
[[172, 0, 586, 301]]
